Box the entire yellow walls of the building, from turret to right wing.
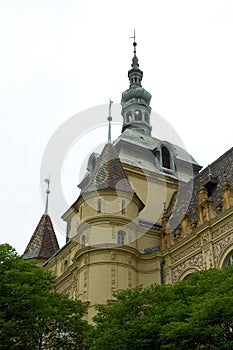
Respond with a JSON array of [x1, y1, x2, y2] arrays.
[[45, 145, 233, 321]]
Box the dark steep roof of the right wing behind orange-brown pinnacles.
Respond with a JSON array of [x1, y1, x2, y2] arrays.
[[168, 148, 233, 228]]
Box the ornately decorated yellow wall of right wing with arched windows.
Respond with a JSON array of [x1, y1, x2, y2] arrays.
[[163, 207, 233, 283]]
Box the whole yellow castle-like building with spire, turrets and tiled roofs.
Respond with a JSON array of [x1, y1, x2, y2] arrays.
[[24, 41, 233, 320]]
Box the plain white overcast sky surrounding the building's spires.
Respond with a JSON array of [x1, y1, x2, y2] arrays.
[[0, 0, 233, 253]]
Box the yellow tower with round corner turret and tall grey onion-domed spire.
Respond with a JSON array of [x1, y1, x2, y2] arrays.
[[44, 36, 200, 320]]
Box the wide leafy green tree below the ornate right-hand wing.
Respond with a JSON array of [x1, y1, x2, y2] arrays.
[[90, 267, 233, 350]]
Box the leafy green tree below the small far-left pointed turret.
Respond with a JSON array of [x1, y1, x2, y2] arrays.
[[0, 244, 89, 350]]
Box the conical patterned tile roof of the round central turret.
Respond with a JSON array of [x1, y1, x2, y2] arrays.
[[81, 143, 134, 194]]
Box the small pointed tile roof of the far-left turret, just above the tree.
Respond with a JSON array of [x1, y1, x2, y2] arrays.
[[23, 214, 59, 259]]
